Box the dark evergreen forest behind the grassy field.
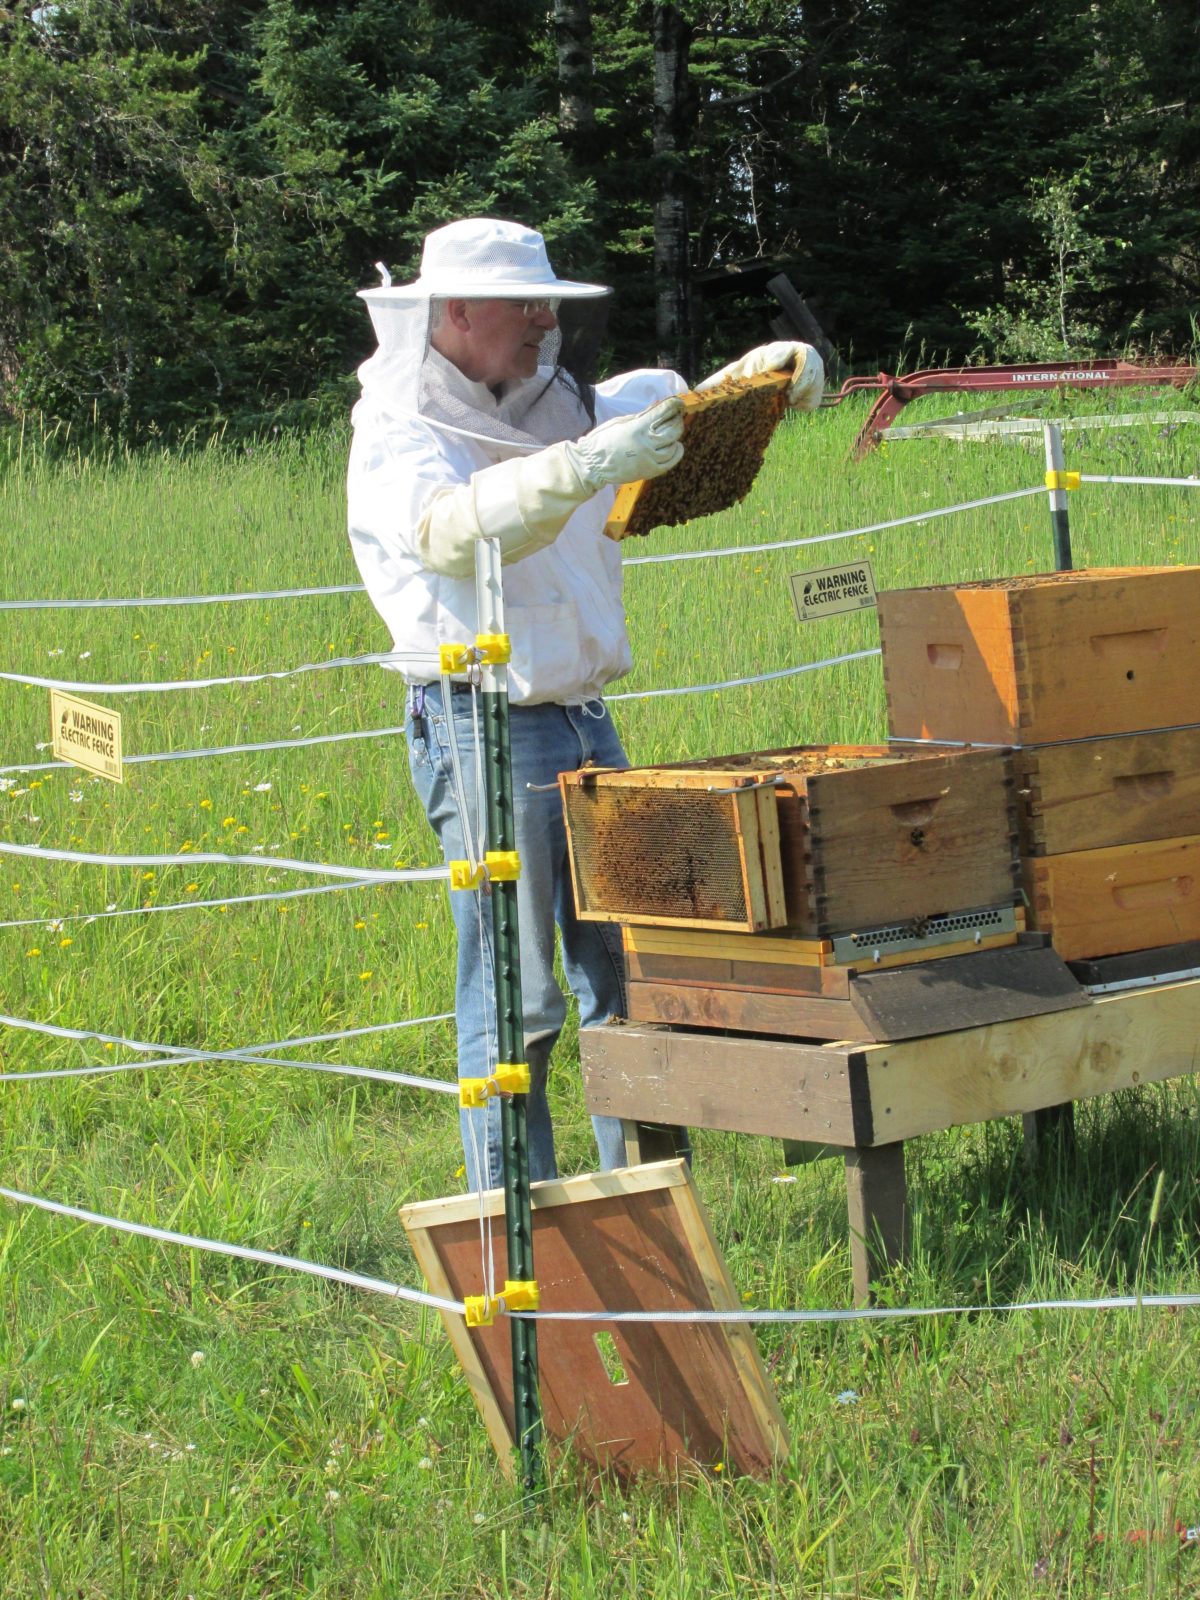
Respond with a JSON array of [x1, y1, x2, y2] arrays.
[[0, 0, 1200, 438]]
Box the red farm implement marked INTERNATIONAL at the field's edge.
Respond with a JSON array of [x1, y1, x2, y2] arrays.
[[826, 362, 1200, 458]]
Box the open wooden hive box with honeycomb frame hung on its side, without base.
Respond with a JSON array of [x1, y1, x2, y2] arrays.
[[560, 744, 1018, 939]]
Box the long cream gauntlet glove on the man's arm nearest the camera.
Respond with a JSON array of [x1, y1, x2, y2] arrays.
[[416, 395, 683, 578]]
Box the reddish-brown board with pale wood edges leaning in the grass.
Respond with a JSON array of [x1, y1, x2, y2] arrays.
[[400, 1160, 789, 1475]]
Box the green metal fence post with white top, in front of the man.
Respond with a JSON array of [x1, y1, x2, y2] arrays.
[[475, 539, 542, 1494]]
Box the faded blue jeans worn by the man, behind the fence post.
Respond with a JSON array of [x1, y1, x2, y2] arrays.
[[408, 685, 629, 1189]]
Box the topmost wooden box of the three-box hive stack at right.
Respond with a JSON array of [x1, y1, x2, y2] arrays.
[[878, 566, 1200, 744]]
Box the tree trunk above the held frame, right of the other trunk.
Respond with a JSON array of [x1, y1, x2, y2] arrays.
[[653, 5, 694, 376]]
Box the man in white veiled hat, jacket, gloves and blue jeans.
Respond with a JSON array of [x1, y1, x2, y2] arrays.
[[349, 218, 824, 1187]]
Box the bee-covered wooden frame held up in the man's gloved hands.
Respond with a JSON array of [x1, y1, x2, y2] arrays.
[[605, 373, 792, 539]]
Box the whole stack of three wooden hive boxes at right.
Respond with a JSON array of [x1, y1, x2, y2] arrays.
[[880, 566, 1200, 966]]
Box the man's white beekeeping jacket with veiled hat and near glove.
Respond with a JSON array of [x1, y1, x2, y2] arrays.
[[349, 219, 686, 704]]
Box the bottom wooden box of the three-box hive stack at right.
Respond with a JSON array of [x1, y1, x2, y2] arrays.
[[1024, 834, 1200, 962]]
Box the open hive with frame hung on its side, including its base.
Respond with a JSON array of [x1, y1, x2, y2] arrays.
[[560, 746, 1019, 1038]]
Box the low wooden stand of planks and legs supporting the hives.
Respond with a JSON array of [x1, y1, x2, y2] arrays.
[[579, 979, 1200, 1299]]
